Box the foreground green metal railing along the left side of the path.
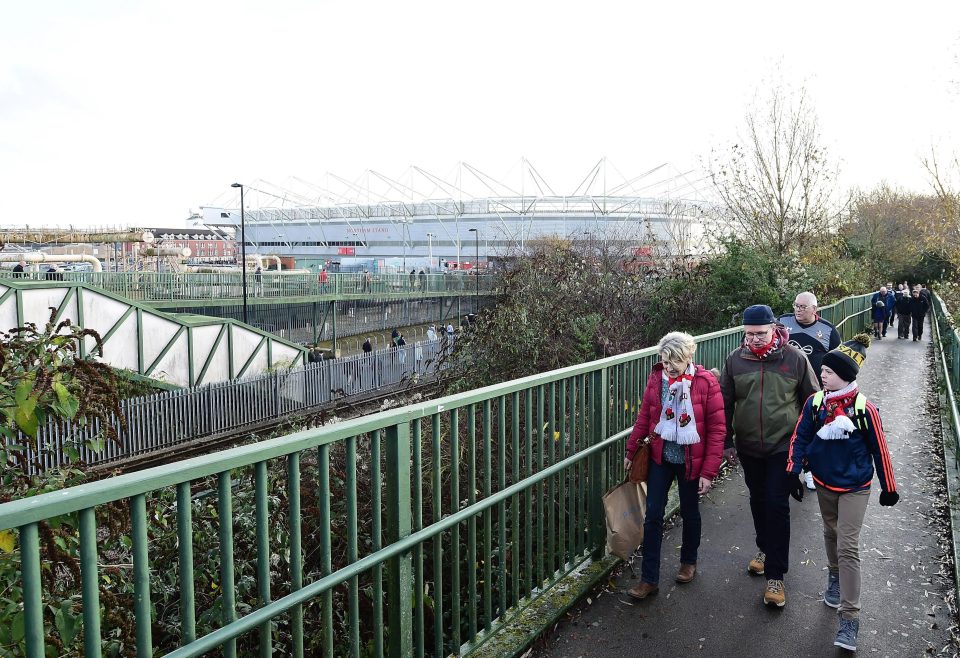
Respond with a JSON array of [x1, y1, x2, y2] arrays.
[[0, 297, 869, 658]]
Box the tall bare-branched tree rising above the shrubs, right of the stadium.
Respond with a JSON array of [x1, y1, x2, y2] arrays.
[[708, 85, 840, 255]]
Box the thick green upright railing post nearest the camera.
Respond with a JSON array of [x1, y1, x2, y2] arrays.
[[386, 422, 413, 658]]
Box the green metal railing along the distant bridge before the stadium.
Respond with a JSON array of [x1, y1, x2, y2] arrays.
[[0, 270, 496, 301]]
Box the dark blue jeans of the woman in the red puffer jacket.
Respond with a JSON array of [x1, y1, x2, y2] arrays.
[[640, 459, 700, 585]]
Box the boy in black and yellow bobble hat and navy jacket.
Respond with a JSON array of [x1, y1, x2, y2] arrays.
[[787, 334, 900, 651]]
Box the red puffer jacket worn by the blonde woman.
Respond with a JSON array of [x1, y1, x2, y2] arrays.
[[626, 363, 727, 480]]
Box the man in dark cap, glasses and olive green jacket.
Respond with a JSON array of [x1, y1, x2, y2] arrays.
[[720, 304, 820, 607]]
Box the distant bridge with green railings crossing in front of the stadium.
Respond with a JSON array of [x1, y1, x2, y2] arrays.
[[0, 270, 497, 352]]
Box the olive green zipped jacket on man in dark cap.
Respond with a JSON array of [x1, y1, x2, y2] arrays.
[[720, 324, 820, 457]]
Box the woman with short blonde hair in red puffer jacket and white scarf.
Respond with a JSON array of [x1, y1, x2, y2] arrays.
[[623, 331, 727, 599]]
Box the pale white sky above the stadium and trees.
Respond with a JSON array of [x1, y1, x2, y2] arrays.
[[0, 0, 960, 227]]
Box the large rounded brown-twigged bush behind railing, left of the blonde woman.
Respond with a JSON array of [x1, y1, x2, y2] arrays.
[[454, 238, 650, 390]]
